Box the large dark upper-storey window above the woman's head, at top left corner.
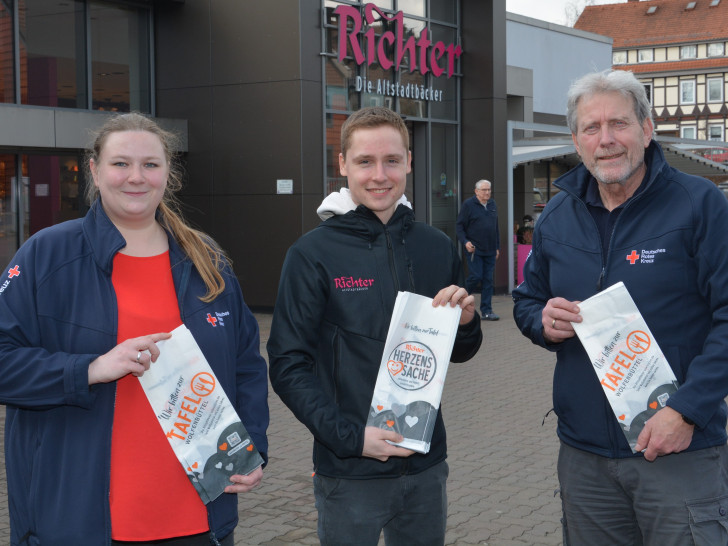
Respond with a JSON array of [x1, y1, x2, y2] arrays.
[[12, 0, 152, 112]]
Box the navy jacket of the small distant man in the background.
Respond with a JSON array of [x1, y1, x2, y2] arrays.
[[455, 196, 500, 256]]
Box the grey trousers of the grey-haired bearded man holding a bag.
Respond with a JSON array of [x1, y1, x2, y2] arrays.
[[558, 442, 728, 546]]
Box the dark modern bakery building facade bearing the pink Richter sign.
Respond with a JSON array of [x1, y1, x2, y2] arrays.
[[0, 0, 506, 307]]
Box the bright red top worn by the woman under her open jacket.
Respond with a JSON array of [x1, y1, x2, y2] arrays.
[[109, 252, 209, 541]]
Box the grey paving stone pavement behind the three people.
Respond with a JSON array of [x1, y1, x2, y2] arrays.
[[0, 295, 561, 546]]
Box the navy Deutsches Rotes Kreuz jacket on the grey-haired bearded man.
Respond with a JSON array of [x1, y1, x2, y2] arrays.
[[513, 142, 728, 457]]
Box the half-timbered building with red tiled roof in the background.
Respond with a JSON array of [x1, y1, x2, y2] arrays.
[[574, 0, 728, 147]]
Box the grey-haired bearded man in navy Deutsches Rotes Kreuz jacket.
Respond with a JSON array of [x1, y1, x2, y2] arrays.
[[513, 70, 728, 546]]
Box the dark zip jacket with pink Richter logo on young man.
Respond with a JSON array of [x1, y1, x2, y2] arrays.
[[268, 205, 483, 479]]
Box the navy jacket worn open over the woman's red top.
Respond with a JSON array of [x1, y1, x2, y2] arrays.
[[0, 201, 268, 546]]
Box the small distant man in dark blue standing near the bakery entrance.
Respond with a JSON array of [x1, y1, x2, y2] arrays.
[[456, 180, 500, 320]]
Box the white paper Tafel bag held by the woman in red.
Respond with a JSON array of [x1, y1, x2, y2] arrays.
[[139, 324, 263, 504]]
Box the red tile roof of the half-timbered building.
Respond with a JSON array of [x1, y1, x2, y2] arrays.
[[574, 0, 728, 49]]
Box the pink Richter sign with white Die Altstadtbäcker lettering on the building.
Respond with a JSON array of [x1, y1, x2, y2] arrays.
[[334, 4, 463, 100]]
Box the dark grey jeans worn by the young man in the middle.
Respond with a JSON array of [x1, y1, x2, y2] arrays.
[[313, 461, 448, 546]]
